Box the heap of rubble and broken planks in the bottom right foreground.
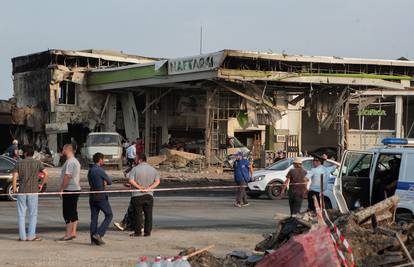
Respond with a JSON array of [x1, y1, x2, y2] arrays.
[[256, 196, 414, 266]]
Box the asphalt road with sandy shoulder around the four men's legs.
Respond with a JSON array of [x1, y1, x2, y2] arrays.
[[0, 190, 289, 266]]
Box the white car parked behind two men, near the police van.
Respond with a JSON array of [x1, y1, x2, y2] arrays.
[[247, 157, 339, 201]]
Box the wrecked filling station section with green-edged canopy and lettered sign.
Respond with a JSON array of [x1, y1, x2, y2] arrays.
[[88, 50, 414, 163]]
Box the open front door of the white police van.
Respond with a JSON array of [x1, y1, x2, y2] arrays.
[[334, 151, 374, 212]]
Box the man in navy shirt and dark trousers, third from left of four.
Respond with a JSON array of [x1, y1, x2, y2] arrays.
[[88, 153, 113, 246]]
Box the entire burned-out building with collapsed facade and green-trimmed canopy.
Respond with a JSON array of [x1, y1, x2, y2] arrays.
[[12, 50, 414, 163]]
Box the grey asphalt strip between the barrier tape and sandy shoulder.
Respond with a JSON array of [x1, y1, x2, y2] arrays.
[[0, 190, 289, 234]]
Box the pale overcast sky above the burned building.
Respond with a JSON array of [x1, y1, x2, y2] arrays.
[[0, 0, 414, 99]]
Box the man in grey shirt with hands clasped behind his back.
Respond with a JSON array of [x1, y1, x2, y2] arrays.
[[128, 153, 160, 236]]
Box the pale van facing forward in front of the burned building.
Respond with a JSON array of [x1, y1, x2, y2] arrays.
[[83, 132, 122, 170]]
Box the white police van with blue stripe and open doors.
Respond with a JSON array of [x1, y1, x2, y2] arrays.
[[333, 138, 414, 216]]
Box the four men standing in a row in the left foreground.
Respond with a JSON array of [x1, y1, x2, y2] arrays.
[[13, 144, 160, 245]]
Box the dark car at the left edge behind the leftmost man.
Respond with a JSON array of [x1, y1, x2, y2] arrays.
[[0, 156, 47, 200]]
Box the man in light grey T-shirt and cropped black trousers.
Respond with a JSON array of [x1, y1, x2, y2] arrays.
[[59, 144, 81, 241]]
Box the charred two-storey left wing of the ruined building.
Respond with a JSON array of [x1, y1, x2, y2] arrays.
[[12, 50, 154, 152]]
